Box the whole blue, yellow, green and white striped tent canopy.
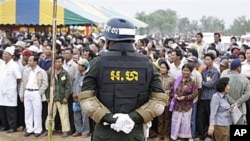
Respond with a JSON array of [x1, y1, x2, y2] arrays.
[[0, 0, 148, 28]]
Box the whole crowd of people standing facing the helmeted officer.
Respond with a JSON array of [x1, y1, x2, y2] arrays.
[[0, 26, 250, 141]]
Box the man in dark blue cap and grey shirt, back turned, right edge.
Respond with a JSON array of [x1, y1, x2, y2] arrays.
[[227, 59, 250, 125]]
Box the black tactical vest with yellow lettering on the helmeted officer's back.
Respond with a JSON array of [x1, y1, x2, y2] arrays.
[[97, 43, 153, 113]]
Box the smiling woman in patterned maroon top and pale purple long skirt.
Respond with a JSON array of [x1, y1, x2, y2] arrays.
[[170, 64, 198, 140]]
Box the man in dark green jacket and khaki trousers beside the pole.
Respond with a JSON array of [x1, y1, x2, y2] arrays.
[[44, 56, 72, 138]]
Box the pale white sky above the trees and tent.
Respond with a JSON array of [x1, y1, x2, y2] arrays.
[[83, 0, 250, 27]]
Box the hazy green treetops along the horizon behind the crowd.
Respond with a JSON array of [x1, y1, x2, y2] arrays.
[[136, 9, 250, 35]]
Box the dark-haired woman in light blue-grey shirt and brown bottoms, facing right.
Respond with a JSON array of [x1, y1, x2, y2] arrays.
[[208, 77, 232, 141]]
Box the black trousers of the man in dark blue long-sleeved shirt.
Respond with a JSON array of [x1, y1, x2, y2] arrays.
[[196, 100, 211, 139]]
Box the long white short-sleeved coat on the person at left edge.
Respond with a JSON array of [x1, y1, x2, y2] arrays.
[[0, 59, 21, 106]]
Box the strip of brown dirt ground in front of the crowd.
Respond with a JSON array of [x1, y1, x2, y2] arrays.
[[0, 132, 153, 141]]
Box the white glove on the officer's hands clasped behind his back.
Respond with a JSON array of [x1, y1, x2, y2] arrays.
[[110, 113, 135, 134]]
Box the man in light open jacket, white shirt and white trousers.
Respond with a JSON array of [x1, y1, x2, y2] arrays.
[[19, 55, 48, 137]]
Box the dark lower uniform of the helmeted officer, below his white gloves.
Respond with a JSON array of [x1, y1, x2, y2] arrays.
[[92, 124, 145, 141]]
